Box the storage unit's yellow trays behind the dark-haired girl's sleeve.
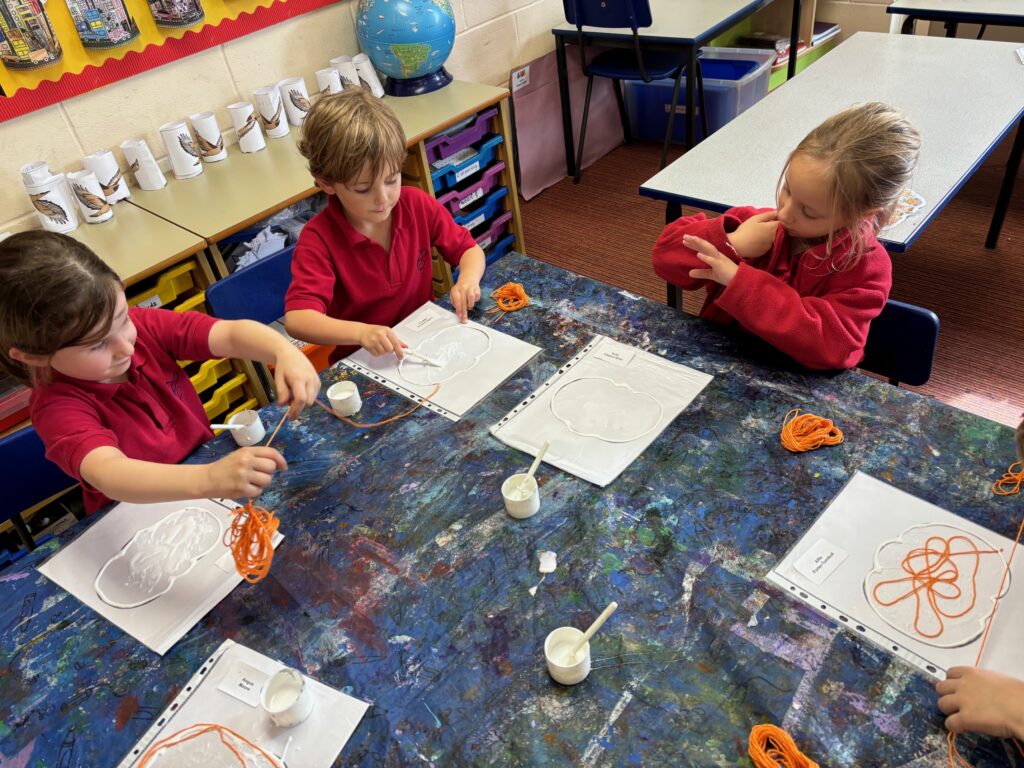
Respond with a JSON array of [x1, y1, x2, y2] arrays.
[[127, 258, 267, 430]]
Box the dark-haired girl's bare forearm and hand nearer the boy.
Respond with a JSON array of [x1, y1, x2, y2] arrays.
[[209, 321, 321, 419]]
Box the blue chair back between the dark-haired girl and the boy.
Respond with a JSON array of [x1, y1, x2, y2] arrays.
[[206, 246, 295, 325]]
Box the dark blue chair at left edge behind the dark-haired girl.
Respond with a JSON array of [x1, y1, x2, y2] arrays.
[[0, 427, 76, 550]]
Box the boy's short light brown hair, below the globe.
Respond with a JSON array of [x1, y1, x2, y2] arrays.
[[298, 88, 406, 184]]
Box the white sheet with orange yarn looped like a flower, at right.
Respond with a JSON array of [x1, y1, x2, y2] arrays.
[[767, 472, 1024, 679]]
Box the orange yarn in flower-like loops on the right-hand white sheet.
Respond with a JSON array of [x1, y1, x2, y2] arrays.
[[871, 535, 999, 638]]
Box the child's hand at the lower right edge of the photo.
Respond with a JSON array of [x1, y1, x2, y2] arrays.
[[935, 667, 1024, 738]]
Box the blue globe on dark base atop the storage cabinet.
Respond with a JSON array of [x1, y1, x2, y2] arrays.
[[355, 0, 455, 96]]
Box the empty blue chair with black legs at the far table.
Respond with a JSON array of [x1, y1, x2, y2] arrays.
[[562, 0, 708, 183]]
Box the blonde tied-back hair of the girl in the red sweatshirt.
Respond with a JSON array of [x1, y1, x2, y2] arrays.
[[779, 101, 921, 268]]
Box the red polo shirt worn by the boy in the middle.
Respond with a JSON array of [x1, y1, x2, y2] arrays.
[[285, 186, 476, 362]]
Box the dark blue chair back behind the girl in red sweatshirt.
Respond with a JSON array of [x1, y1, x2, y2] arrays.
[[859, 299, 939, 386]]
